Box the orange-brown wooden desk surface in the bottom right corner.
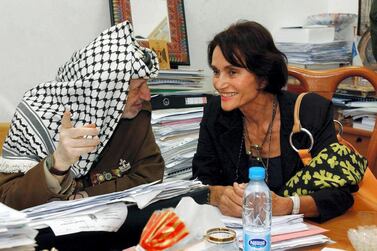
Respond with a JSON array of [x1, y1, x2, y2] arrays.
[[305, 211, 377, 250]]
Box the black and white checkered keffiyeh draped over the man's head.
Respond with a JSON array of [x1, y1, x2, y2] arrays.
[[0, 21, 158, 177]]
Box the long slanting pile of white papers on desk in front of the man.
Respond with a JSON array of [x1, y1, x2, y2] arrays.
[[24, 180, 203, 235]]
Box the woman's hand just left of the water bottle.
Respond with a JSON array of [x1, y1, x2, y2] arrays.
[[209, 182, 246, 217]]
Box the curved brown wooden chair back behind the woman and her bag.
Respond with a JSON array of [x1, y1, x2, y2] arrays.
[[288, 66, 377, 211]]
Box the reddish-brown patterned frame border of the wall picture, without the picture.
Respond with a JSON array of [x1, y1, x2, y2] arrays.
[[109, 0, 190, 68]]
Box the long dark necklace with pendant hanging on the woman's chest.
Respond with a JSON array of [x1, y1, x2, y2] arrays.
[[243, 97, 277, 177]]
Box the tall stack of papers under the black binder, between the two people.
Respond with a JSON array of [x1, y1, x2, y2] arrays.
[[152, 107, 203, 180]]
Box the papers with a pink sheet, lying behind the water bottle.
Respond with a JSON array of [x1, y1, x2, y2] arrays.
[[222, 214, 330, 250]]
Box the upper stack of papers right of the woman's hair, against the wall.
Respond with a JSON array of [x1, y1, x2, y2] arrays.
[[276, 41, 352, 65]]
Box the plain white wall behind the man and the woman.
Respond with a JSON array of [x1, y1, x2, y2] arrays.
[[0, 0, 358, 122]]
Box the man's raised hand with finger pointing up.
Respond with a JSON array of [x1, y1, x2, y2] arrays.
[[54, 111, 100, 171]]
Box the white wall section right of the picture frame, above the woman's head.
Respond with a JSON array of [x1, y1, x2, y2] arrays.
[[185, 0, 358, 72]]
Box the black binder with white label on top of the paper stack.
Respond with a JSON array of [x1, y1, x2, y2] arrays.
[[151, 93, 213, 110]]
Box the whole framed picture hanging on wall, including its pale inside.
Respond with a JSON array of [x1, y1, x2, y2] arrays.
[[109, 0, 190, 68]]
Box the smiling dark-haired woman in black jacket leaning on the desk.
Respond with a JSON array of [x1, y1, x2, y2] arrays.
[[192, 21, 358, 221]]
